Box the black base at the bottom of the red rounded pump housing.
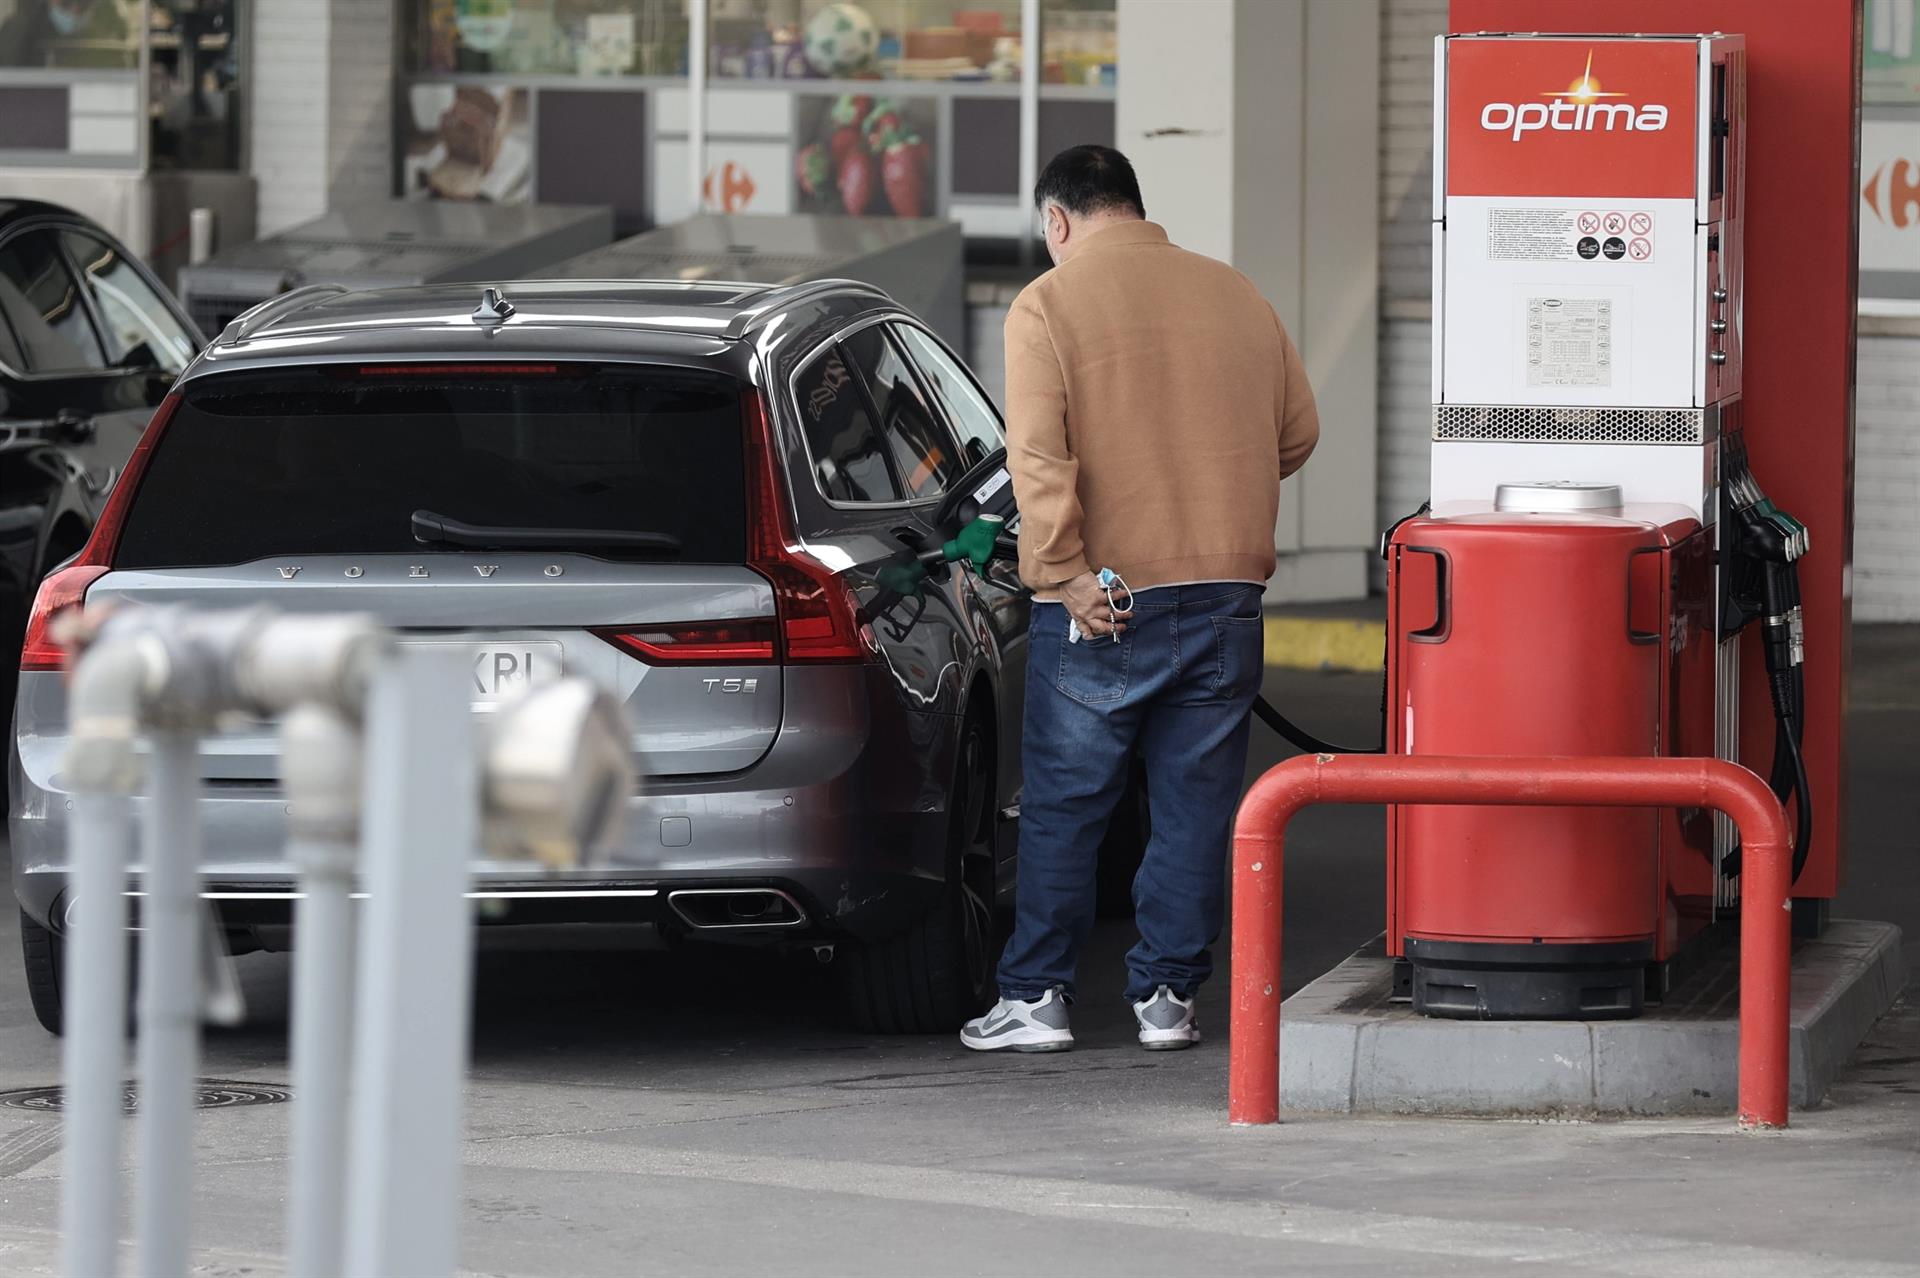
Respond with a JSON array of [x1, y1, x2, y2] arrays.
[[1405, 936, 1653, 1021]]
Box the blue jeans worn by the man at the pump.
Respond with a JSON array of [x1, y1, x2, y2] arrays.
[[1000, 583, 1263, 1000]]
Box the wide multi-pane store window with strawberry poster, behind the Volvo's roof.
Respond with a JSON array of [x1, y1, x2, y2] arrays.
[[397, 0, 1116, 242]]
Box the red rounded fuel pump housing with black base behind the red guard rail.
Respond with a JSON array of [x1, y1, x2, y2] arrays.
[[1386, 485, 1715, 1019]]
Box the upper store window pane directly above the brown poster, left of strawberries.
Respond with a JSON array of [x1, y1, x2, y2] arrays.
[[403, 0, 687, 77]]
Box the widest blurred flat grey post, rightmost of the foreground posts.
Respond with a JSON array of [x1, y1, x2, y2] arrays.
[[344, 649, 480, 1278]]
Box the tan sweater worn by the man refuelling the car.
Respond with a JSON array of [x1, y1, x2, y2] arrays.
[[1006, 221, 1319, 591]]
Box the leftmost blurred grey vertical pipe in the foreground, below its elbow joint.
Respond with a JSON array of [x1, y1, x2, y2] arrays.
[[60, 791, 132, 1278]]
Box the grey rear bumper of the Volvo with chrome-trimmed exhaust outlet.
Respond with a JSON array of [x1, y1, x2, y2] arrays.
[[8, 668, 958, 940]]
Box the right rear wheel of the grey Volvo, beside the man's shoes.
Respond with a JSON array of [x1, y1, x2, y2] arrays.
[[839, 720, 1000, 1034]]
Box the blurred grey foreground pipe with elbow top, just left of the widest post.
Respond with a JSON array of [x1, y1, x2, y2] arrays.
[[280, 704, 361, 1278]]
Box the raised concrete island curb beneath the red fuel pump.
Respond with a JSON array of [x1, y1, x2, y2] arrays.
[[1281, 919, 1907, 1115]]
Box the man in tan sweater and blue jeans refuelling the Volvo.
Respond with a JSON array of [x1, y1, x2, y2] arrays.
[[960, 146, 1319, 1052]]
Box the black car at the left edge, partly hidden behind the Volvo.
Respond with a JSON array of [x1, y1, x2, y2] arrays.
[[0, 198, 204, 666]]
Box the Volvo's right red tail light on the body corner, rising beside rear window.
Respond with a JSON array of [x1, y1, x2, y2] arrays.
[[743, 390, 874, 664]]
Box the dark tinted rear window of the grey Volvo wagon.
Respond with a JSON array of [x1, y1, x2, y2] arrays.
[[113, 365, 747, 568]]
